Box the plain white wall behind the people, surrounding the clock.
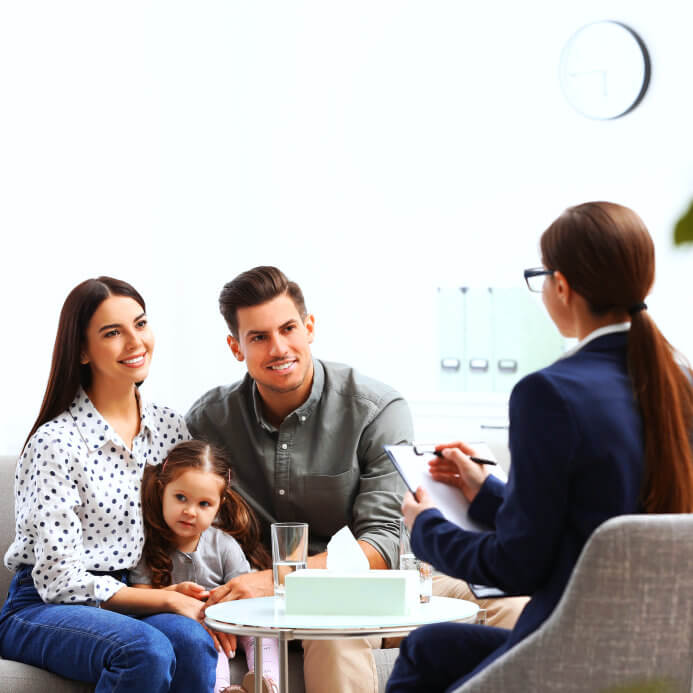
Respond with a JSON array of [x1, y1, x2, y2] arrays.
[[0, 0, 693, 453]]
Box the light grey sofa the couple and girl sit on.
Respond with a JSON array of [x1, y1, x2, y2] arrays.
[[0, 456, 397, 693]]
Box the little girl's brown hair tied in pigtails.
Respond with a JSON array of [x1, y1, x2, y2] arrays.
[[142, 440, 272, 587]]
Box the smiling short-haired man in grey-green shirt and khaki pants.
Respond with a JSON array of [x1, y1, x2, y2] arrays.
[[186, 267, 519, 693]]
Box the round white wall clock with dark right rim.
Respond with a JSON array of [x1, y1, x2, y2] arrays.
[[560, 22, 650, 120]]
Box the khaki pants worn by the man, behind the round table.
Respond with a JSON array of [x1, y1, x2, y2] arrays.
[[303, 575, 528, 693]]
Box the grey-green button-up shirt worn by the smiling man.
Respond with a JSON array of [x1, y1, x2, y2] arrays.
[[186, 359, 413, 567]]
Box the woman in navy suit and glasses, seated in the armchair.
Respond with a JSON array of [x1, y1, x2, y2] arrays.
[[387, 202, 693, 693]]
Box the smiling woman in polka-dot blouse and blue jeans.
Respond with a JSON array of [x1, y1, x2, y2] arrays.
[[0, 277, 217, 693]]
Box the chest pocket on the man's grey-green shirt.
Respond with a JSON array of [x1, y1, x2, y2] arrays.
[[299, 469, 359, 539]]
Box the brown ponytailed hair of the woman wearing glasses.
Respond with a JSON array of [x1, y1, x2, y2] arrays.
[[541, 202, 693, 513]]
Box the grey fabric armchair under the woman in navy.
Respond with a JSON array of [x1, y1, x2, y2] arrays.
[[455, 515, 693, 693]]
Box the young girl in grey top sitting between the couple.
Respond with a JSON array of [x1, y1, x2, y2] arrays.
[[130, 440, 279, 693]]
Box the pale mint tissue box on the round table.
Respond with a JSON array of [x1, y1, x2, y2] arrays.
[[285, 569, 419, 616]]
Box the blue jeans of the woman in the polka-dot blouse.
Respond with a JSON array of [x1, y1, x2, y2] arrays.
[[0, 566, 217, 693]]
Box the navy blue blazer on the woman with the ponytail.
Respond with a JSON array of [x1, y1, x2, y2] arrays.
[[412, 332, 644, 658]]
